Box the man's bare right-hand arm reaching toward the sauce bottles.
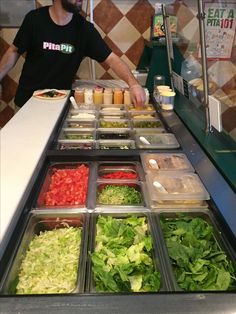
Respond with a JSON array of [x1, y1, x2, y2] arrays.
[[105, 52, 146, 106]]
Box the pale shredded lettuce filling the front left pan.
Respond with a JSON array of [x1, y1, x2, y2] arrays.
[[16, 227, 81, 294]]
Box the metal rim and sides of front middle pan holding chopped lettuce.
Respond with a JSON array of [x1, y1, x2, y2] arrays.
[[86, 212, 169, 293]]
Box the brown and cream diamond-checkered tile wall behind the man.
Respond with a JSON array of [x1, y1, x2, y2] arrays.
[[0, 0, 236, 137]]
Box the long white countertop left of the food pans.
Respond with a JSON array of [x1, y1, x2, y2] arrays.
[[0, 91, 69, 243]]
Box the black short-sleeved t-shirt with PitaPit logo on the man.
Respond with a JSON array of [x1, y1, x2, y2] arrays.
[[13, 6, 111, 107]]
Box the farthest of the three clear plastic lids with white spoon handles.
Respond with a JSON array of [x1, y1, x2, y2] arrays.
[[135, 133, 180, 149]]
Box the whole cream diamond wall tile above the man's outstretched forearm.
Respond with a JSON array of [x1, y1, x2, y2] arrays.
[[108, 17, 140, 53]]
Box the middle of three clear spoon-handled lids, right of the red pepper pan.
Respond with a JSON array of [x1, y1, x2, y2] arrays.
[[141, 153, 194, 172]]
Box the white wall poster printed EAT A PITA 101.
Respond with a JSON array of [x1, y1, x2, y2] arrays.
[[205, 2, 236, 60]]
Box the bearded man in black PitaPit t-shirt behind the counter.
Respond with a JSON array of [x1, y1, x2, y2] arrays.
[[0, 0, 145, 107]]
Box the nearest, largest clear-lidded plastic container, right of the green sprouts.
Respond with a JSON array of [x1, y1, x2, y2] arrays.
[[146, 171, 210, 207]]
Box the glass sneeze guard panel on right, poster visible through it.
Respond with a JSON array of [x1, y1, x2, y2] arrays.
[[165, 0, 236, 190]]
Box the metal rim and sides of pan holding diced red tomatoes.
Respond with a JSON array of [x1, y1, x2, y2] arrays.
[[35, 162, 91, 210]]
